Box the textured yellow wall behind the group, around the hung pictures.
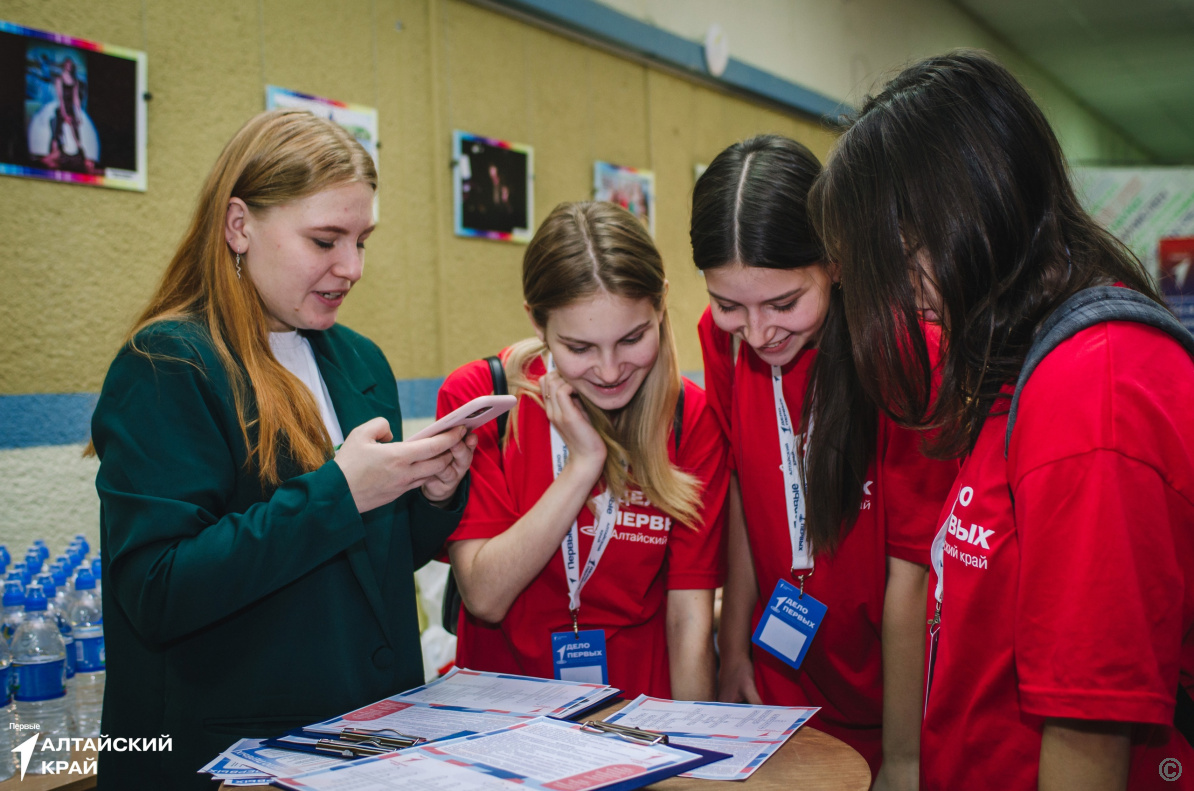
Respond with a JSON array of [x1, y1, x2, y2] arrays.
[[0, 0, 832, 394]]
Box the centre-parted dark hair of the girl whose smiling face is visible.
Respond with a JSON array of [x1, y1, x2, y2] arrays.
[[689, 135, 876, 553]]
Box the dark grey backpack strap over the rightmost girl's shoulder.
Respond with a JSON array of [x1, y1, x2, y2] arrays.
[[1003, 286, 1194, 458]]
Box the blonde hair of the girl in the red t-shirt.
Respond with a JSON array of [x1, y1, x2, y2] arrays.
[[505, 202, 700, 526]]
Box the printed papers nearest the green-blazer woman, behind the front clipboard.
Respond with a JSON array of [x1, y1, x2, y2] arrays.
[[199, 668, 618, 785]]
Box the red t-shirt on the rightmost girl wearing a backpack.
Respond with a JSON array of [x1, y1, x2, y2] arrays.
[[921, 323, 1194, 789]]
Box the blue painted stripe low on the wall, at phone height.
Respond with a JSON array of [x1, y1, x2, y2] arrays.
[[0, 370, 704, 450]]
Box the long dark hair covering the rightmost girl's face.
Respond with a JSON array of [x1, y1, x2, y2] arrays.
[[810, 50, 1158, 458]]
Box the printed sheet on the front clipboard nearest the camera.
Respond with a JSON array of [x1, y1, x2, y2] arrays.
[[275, 717, 724, 791]]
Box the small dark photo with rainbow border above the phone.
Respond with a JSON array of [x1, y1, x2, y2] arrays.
[[451, 130, 535, 244]]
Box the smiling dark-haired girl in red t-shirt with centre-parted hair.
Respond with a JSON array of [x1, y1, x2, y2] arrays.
[[691, 135, 956, 786]]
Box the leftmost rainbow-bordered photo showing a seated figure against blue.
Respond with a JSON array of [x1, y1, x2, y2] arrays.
[[0, 22, 147, 191]]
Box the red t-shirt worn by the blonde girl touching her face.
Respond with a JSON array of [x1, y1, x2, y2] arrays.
[[438, 360, 728, 698]]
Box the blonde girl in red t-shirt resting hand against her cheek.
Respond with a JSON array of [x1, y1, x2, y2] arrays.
[[438, 203, 727, 699]]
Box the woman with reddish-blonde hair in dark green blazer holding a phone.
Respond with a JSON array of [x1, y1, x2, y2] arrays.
[[92, 111, 475, 790]]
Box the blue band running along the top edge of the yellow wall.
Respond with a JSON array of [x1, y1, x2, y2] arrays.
[[496, 0, 853, 123]]
